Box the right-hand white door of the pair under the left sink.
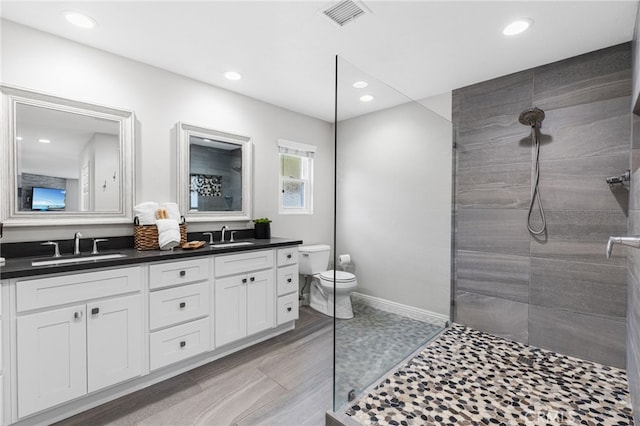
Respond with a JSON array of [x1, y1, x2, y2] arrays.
[[87, 294, 142, 392]]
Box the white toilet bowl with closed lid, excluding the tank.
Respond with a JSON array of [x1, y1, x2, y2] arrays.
[[310, 270, 358, 319]]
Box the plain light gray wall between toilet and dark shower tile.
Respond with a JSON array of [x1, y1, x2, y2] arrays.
[[336, 102, 452, 317]]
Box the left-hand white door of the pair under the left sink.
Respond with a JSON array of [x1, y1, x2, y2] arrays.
[[17, 305, 87, 417]]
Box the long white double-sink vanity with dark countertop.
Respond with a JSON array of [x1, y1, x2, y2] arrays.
[[0, 238, 302, 425]]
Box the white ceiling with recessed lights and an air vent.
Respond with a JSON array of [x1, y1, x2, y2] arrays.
[[0, 0, 638, 122]]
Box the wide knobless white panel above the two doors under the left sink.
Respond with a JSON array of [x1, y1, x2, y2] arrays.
[[16, 266, 142, 312]]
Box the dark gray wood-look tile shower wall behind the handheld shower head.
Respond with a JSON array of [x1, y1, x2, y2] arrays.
[[453, 43, 640, 367]]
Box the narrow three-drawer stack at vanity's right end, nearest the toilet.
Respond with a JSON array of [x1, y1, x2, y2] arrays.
[[276, 246, 299, 325]]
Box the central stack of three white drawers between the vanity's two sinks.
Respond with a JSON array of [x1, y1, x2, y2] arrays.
[[149, 258, 211, 370]]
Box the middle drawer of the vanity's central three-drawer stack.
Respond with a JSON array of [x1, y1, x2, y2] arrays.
[[149, 281, 209, 330]]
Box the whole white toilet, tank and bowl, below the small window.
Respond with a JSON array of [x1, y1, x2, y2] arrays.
[[298, 244, 358, 319]]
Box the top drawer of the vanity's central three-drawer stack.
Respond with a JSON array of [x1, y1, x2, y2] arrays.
[[149, 257, 209, 289]]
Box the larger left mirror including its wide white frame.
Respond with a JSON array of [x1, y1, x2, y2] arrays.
[[0, 86, 134, 226]]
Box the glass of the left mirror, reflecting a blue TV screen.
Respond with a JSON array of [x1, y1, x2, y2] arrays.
[[16, 103, 121, 212]]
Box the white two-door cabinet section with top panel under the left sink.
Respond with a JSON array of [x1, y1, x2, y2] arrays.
[[16, 267, 143, 418]]
